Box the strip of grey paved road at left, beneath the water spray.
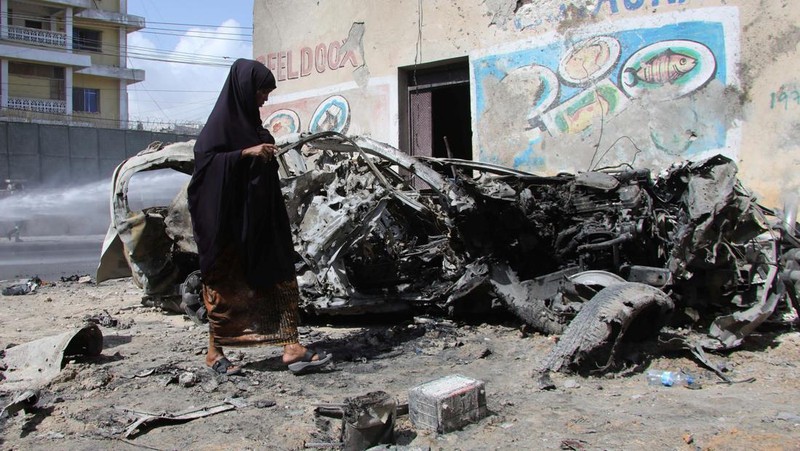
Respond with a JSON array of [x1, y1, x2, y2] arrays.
[[0, 235, 104, 281]]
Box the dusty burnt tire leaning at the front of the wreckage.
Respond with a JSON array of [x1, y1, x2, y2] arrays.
[[539, 282, 675, 376]]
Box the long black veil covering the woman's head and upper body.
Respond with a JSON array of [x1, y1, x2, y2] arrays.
[[188, 59, 295, 287]]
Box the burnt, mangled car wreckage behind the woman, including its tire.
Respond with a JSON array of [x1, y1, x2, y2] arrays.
[[97, 132, 800, 373]]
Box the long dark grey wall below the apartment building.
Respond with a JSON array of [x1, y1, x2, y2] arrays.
[[0, 122, 196, 187]]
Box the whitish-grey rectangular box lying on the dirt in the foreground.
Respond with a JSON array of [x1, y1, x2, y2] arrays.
[[408, 374, 487, 434]]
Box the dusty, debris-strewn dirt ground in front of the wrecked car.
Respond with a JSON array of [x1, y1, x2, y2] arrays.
[[0, 279, 800, 450]]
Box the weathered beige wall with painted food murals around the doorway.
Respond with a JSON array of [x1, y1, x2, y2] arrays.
[[254, 0, 800, 205]]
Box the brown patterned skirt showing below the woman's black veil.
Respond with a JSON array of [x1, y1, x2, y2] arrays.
[[203, 248, 300, 346]]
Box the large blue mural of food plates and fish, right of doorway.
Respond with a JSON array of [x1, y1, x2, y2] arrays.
[[470, 7, 740, 172]]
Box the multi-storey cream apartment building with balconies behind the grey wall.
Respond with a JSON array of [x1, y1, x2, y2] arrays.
[[0, 0, 145, 128]]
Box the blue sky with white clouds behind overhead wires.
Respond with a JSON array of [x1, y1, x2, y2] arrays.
[[128, 0, 253, 129]]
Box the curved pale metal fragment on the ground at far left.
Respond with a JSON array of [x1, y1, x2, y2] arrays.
[[0, 324, 103, 391]]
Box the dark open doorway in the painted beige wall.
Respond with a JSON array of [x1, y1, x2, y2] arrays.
[[405, 60, 472, 160]]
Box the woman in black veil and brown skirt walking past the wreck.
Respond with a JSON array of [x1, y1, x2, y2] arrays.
[[189, 59, 331, 375]]
